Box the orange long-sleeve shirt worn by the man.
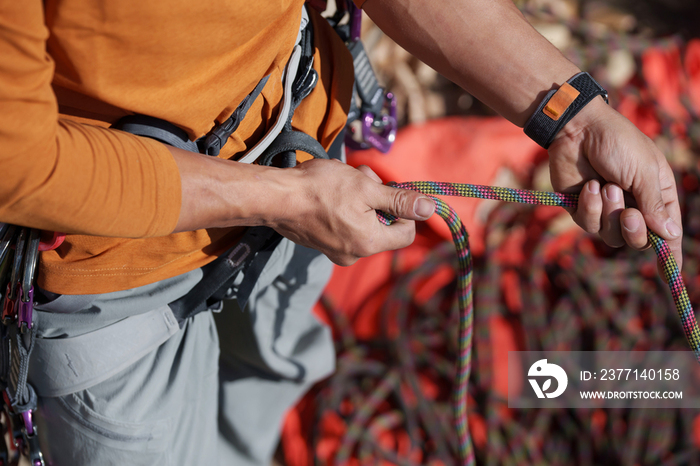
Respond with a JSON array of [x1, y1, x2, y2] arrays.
[[0, 0, 352, 294]]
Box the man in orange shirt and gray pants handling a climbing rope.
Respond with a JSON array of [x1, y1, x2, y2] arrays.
[[0, 0, 681, 465]]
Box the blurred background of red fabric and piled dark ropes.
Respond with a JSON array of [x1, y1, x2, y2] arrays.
[[277, 0, 700, 466]]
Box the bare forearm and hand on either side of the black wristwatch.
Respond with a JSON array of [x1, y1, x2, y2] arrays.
[[363, 0, 682, 276]]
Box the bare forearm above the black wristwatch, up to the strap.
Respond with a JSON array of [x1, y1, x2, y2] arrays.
[[363, 0, 580, 127]]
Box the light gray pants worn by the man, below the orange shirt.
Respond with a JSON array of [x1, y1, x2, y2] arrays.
[[30, 239, 334, 466]]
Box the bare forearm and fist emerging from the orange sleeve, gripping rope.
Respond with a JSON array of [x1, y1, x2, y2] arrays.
[[168, 147, 435, 265]]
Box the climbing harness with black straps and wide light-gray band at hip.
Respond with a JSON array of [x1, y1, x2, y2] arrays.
[[17, 7, 342, 414]]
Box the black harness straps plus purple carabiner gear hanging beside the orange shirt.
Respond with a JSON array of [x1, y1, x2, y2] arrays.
[[112, 2, 396, 324]]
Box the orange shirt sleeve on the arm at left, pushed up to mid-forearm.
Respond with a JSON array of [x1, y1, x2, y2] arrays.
[[0, 0, 181, 238]]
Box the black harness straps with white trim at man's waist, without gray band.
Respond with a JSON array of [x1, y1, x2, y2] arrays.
[[112, 4, 329, 316]]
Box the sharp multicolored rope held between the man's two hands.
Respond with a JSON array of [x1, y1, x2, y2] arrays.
[[377, 181, 700, 466]]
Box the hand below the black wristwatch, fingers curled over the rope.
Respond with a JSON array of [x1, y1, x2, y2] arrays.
[[549, 98, 683, 268]]
